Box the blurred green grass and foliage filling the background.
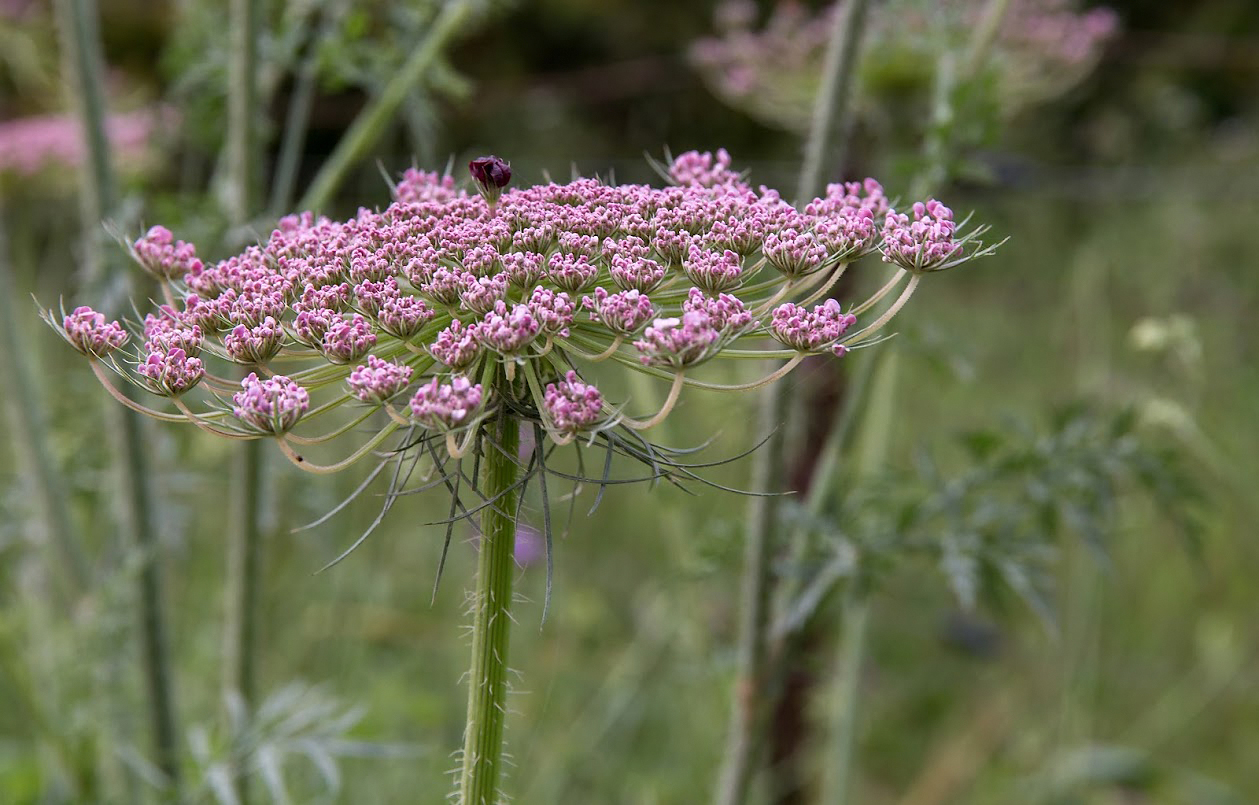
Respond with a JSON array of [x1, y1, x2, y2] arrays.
[[0, 0, 1259, 805]]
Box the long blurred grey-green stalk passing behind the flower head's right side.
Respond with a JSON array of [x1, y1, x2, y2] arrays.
[[714, 6, 866, 805]]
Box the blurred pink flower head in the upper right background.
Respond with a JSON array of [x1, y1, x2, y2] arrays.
[[687, 0, 1118, 133]]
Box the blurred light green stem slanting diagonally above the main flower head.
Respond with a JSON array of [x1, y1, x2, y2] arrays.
[[298, 0, 472, 210]]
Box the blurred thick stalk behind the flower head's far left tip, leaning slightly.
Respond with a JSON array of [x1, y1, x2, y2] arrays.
[[57, 0, 183, 801]]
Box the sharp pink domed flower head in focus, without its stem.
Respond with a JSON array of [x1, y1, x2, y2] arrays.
[[54, 151, 992, 453]]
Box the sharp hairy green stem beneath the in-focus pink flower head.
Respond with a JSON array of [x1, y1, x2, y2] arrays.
[[460, 412, 520, 805]]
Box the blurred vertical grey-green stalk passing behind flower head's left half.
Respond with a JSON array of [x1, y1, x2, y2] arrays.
[[223, 0, 262, 805]]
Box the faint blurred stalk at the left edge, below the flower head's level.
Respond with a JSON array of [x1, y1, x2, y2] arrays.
[[0, 208, 91, 603]]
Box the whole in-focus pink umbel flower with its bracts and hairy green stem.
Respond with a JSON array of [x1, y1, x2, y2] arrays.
[[45, 151, 993, 805]]
